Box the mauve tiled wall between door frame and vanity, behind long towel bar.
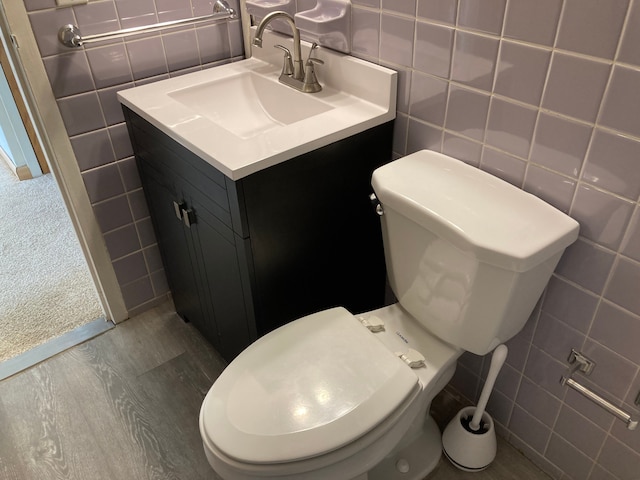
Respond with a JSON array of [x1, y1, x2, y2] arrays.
[[24, 0, 244, 315]]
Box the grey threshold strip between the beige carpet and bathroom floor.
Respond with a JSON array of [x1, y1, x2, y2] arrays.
[[0, 317, 115, 381]]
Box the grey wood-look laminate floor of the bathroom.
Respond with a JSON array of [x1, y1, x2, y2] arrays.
[[0, 303, 548, 480]]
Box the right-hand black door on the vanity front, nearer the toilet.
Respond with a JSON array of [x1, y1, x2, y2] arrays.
[[190, 204, 252, 360]]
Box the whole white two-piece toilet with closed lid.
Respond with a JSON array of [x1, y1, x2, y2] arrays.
[[200, 150, 578, 480]]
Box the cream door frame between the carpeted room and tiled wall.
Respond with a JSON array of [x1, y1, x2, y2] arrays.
[[0, 0, 128, 323]]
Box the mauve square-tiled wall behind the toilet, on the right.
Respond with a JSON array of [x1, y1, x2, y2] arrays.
[[352, 0, 640, 480]]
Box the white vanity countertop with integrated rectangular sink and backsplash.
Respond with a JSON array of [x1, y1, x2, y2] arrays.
[[118, 27, 397, 180]]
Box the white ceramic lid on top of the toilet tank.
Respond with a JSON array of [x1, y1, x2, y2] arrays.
[[372, 150, 579, 272]]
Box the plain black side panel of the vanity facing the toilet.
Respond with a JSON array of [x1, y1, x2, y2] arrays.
[[238, 123, 393, 335]]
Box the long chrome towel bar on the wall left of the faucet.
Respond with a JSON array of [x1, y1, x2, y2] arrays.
[[58, 0, 237, 48]]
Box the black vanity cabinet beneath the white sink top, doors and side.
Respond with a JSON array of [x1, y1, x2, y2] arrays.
[[123, 107, 393, 360]]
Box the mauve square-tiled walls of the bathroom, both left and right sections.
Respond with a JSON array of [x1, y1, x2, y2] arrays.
[[20, 0, 640, 480]]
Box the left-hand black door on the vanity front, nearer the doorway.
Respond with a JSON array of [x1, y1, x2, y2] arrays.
[[138, 160, 206, 336]]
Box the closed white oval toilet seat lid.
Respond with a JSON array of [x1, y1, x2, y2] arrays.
[[202, 308, 418, 463]]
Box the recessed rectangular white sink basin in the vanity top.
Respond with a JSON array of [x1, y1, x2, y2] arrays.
[[168, 72, 334, 139]]
